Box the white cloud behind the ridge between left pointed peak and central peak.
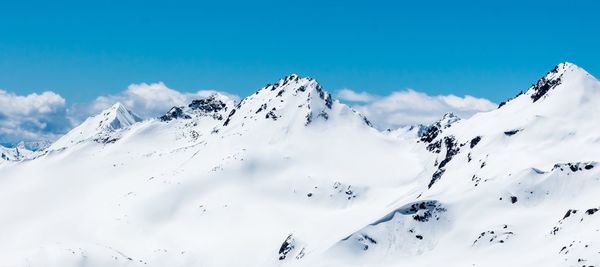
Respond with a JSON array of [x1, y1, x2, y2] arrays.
[[73, 82, 238, 120]]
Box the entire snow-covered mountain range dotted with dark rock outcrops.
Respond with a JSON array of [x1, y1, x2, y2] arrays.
[[0, 63, 600, 266]]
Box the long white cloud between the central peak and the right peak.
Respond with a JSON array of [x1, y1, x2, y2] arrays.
[[338, 89, 498, 129]]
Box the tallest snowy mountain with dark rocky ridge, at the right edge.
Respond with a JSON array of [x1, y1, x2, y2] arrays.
[[326, 63, 600, 266]]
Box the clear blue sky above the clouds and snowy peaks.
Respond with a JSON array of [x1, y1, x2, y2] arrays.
[[0, 0, 600, 103]]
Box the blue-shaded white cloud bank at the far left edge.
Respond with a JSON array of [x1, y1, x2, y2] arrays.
[[0, 90, 71, 143]]
